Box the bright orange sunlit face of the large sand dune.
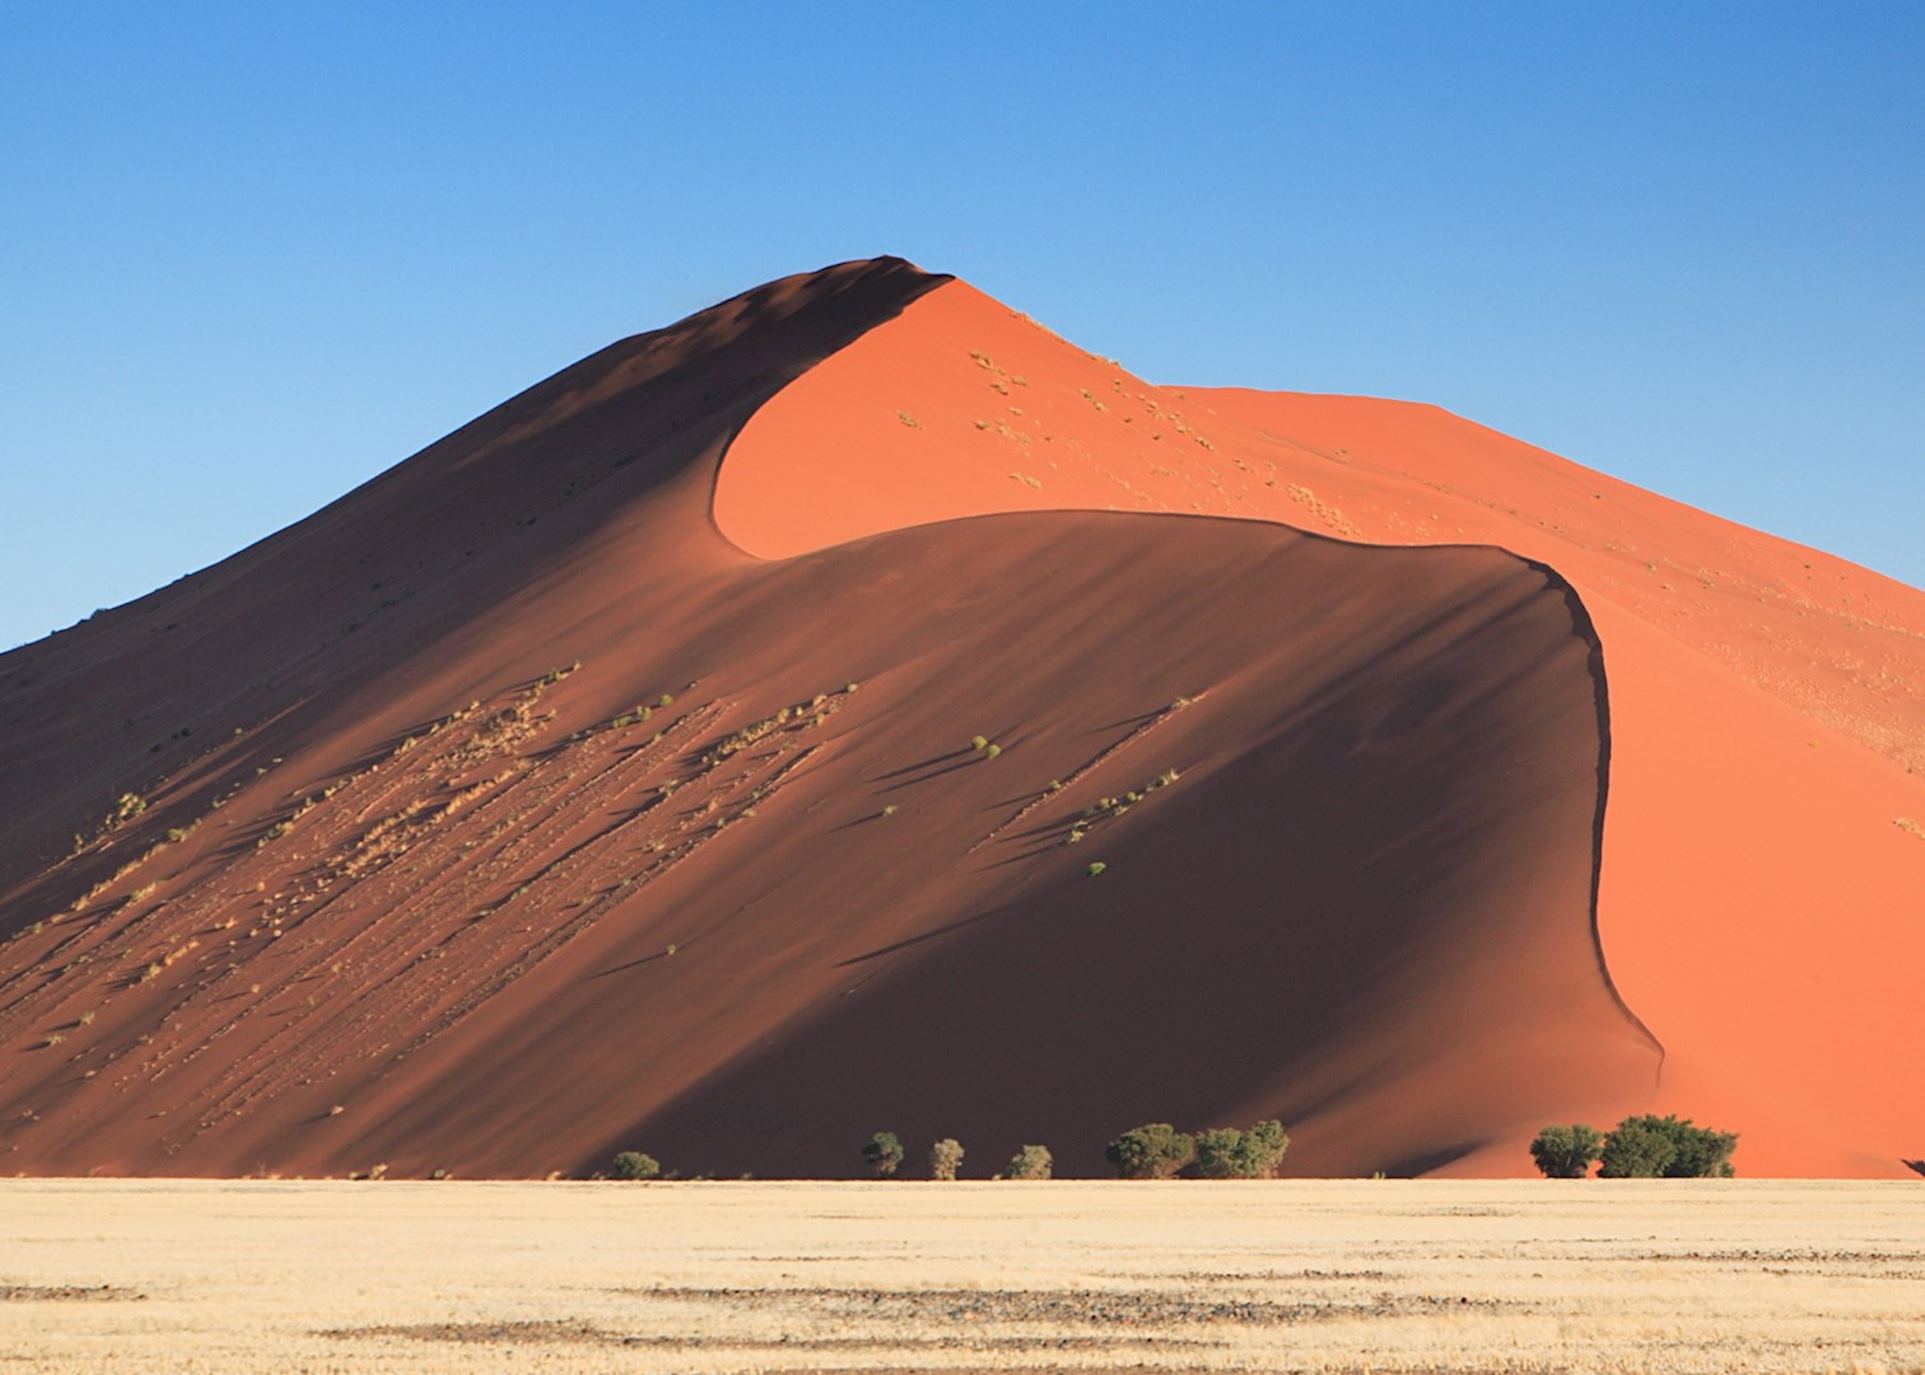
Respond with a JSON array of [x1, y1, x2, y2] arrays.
[[714, 283, 1925, 1177]]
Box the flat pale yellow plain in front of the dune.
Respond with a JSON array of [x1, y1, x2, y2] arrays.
[[0, 1180, 1925, 1373]]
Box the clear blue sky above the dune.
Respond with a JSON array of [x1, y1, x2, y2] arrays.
[[0, 0, 1925, 645]]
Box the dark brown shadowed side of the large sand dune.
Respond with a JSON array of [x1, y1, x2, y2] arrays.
[[0, 260, 1657, 1175]]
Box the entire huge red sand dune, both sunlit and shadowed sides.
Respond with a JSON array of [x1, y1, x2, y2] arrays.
[[0, 260, 1925, 1175]]
